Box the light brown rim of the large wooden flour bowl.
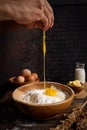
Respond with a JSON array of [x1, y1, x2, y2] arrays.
[[12, 81, 75, 107]]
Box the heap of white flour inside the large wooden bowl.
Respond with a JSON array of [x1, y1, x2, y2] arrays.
[[22, 89, 66, 104]]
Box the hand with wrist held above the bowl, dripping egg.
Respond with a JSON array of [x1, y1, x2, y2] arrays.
[[0, 0, 54, 30]]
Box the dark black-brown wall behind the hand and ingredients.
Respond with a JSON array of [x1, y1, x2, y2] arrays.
[[0, 0, 87, 91]]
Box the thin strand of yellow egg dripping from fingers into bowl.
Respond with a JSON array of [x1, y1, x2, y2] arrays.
[[43, 31, 46, 89]]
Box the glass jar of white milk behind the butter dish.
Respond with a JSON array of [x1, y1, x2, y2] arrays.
[[75, 63, 86, 83]]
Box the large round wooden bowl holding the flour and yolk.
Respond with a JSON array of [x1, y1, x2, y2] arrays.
[[12, 82, 74, 120]]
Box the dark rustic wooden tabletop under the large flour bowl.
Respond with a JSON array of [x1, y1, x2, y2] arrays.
[[0, 85, 87, 130]]
